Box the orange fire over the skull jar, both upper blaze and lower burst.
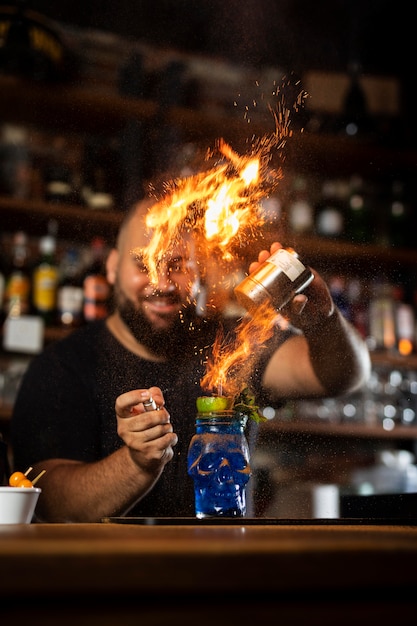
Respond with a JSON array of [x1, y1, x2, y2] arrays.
[[133, 79, 305, 395]]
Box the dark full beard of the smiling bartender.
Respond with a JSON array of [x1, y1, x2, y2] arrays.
[[116, 291, 195, 357]]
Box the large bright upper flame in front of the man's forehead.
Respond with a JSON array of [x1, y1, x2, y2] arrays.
[[133, 139, 282, 282]]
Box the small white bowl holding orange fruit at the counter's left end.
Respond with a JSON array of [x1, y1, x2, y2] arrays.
[[0, 487, 42, 524]]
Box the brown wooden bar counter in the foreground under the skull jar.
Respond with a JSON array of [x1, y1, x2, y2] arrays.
[[0, 523, 417, 626]]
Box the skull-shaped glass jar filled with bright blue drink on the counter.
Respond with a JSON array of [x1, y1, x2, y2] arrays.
[[187, 410, 251, 518]]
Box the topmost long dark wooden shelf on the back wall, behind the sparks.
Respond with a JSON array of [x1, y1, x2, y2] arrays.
[[0, 76, 417, 176]]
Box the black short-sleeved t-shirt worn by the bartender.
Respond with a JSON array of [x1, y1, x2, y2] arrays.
[[11, 320, 285, 516]]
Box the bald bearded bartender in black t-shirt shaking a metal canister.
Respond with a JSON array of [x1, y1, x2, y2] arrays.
[[11, 194, 370, 522]]
